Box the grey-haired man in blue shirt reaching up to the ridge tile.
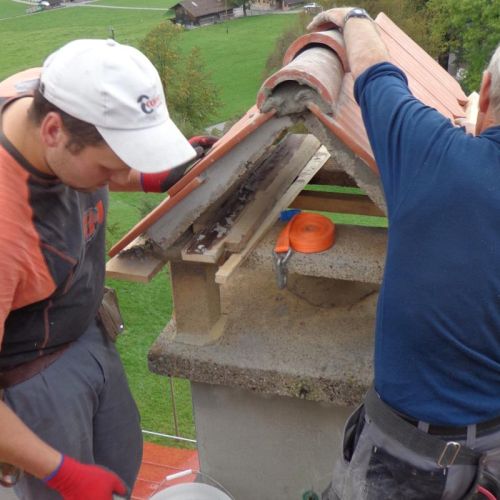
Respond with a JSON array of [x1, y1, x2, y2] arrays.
[[310, 4, 500, 500]]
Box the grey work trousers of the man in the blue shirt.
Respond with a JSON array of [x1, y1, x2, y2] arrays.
[[323, 404, 500, 500]]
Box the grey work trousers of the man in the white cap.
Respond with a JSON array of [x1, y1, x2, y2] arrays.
[[4, 324, 142, 500]]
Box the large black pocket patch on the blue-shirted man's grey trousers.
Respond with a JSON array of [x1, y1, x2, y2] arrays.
[[366, 446, 447, 500]]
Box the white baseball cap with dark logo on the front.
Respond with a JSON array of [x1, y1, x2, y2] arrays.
[[40, 40, 196, 173]]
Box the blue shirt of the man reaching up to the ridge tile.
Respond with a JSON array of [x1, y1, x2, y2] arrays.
[[355, 63, 500, 425]]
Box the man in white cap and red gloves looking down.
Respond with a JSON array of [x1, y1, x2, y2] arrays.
[[0, 40, 211, 500]]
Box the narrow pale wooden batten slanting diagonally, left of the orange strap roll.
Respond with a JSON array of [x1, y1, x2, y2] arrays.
[[215, 146, 330, 285]]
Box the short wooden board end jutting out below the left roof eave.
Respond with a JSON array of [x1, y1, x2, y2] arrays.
[[106, 236, 165, 283]]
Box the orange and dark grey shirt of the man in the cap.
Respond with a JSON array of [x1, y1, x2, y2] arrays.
[[0, 99, 108, 370]]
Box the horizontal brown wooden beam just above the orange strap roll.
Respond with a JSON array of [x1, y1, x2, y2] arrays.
[[290, 191, 385, 217]]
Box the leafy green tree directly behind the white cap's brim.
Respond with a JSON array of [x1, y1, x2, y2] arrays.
[[140, 21, 220, 135]]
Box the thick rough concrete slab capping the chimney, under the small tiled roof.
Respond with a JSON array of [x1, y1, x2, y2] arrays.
[[149, 268, 378, 406]]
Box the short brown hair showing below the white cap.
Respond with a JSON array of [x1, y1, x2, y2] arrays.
[[28, 89, 104, 154]]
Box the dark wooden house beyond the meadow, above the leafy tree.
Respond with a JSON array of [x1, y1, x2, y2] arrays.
[[172, 0, 234, 26]]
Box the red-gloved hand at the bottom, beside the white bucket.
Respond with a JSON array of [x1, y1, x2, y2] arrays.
[[43, 455, 127, 500]]
